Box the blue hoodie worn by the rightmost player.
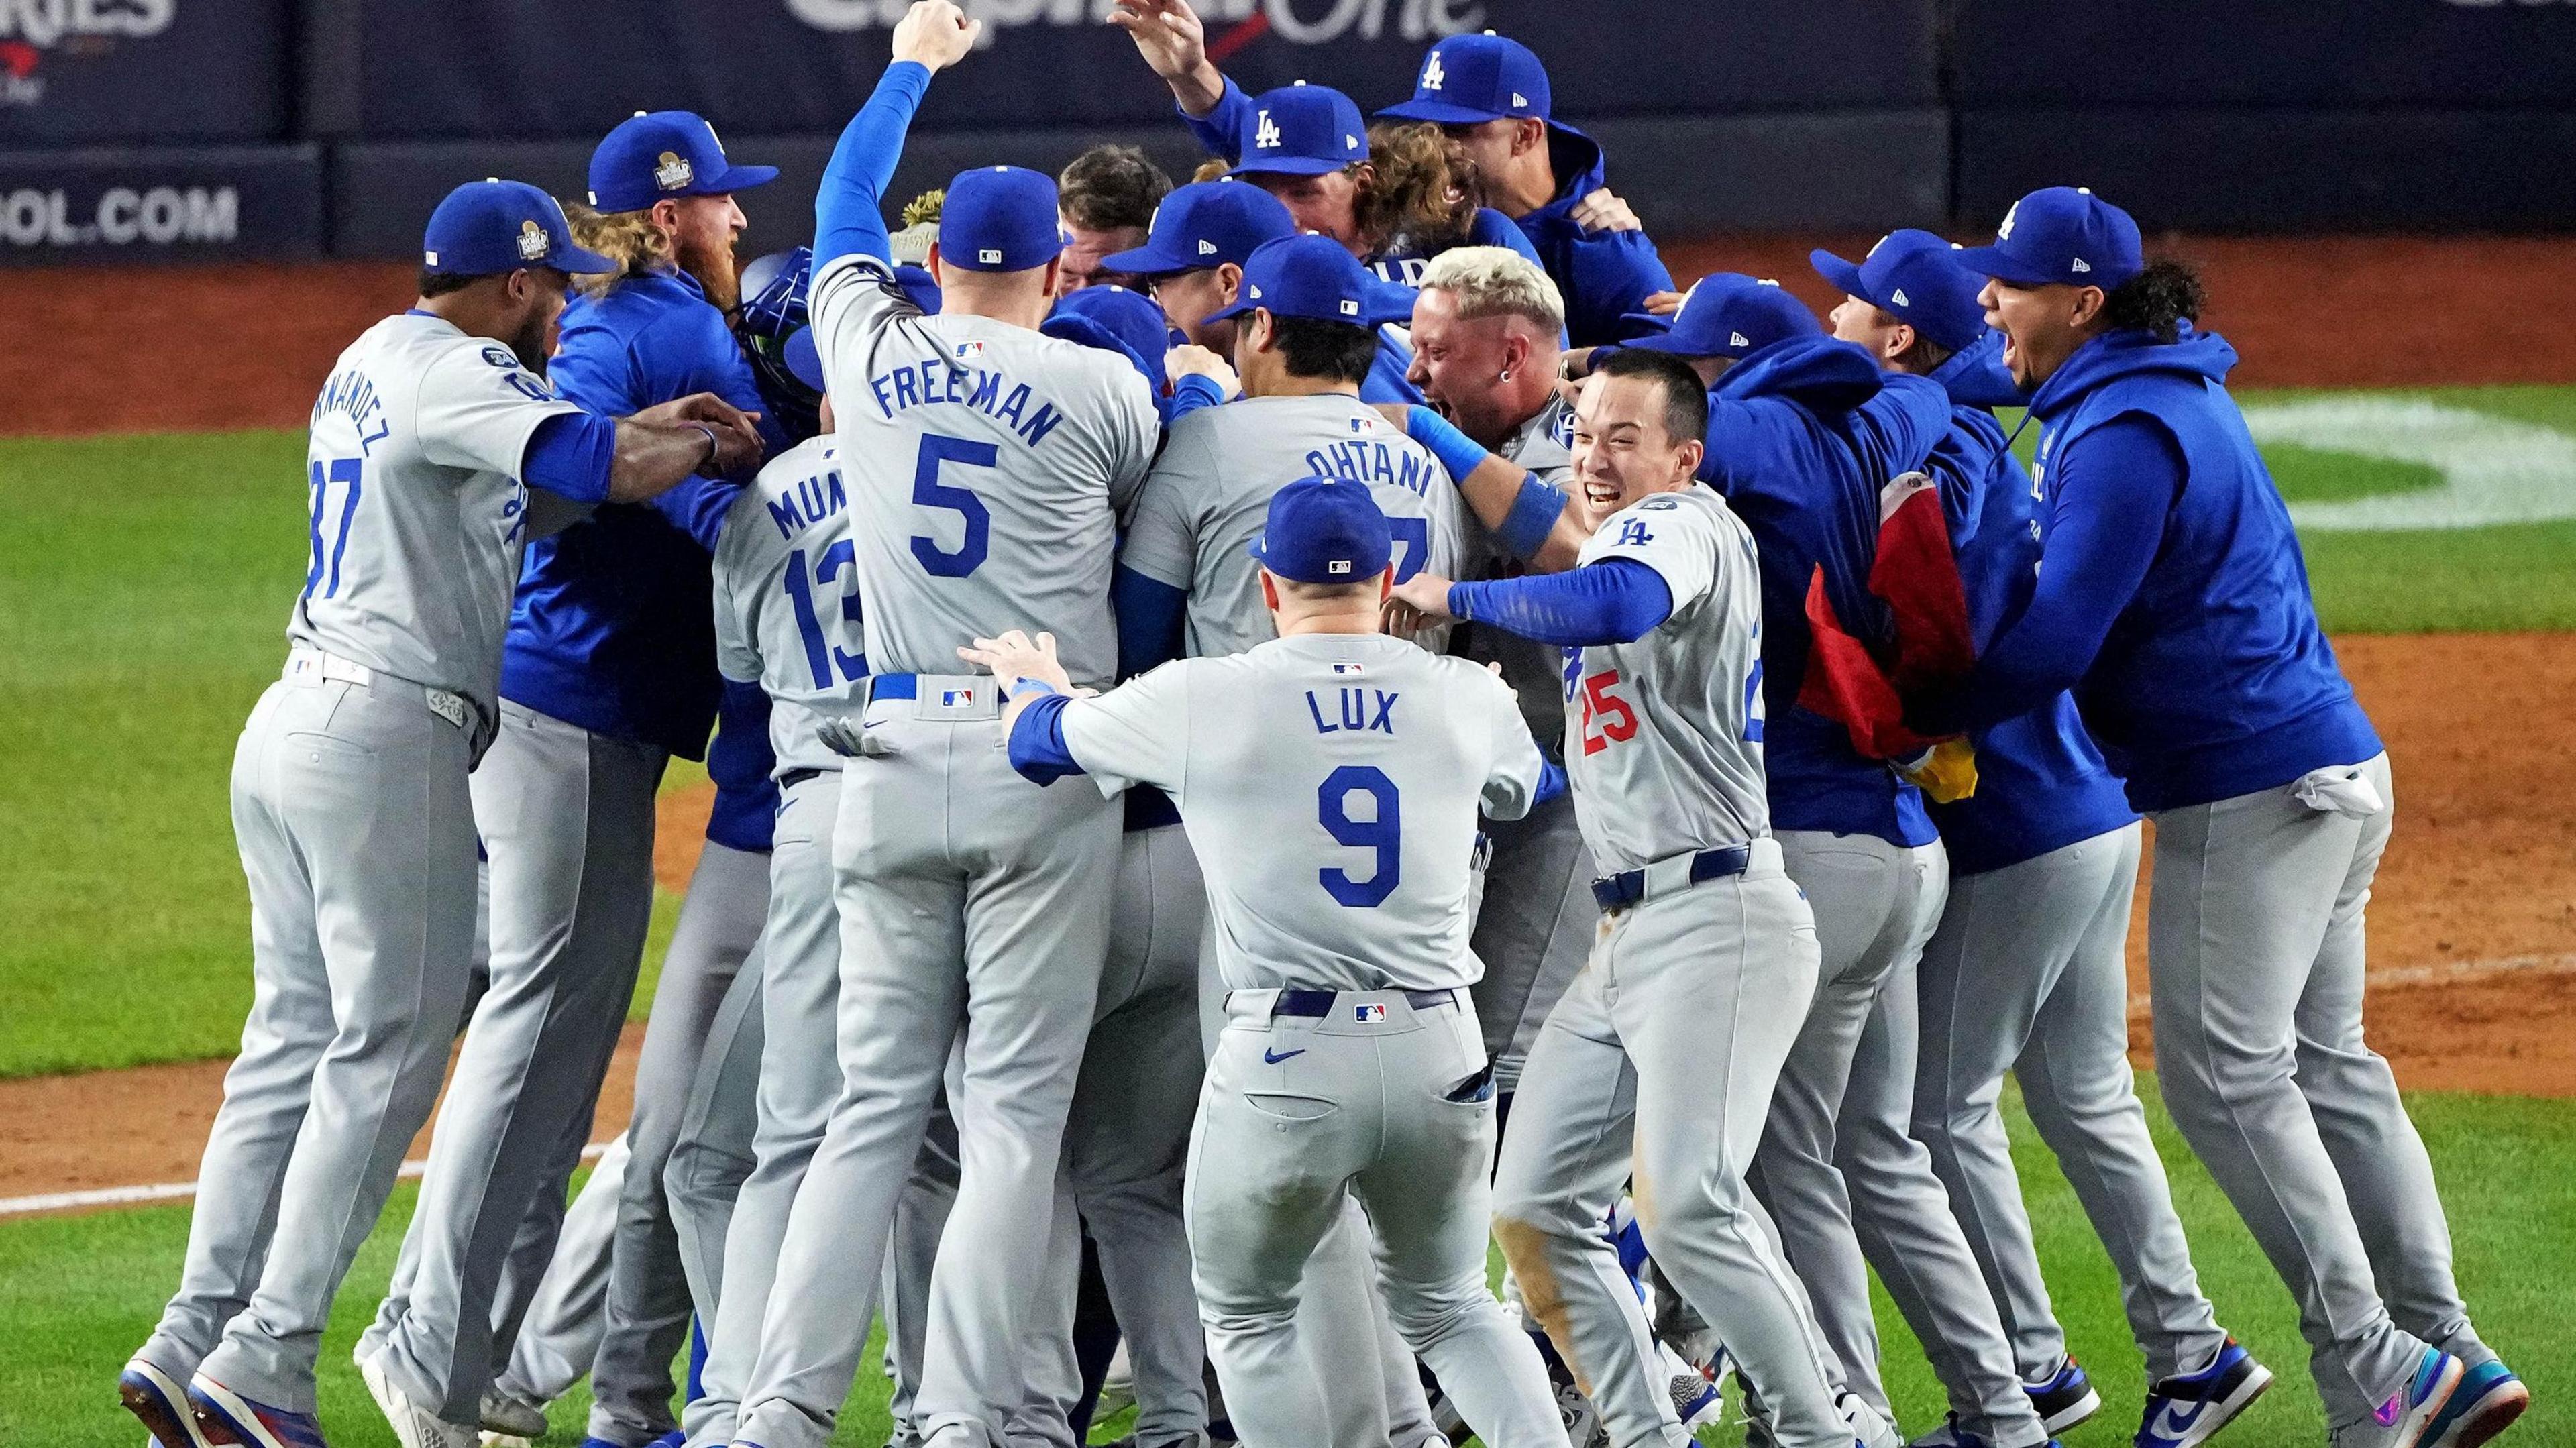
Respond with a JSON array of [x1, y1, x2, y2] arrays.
[[1909, 330, 2380, 812]]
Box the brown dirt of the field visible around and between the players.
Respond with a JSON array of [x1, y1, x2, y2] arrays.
[[0, 235, 2576, 1198]]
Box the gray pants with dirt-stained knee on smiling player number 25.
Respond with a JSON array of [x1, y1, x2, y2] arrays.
[[1494, 840, 1852, 1448]]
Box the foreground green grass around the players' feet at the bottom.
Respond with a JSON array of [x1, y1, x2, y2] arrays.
[[0, 1077, 2576, 1448]]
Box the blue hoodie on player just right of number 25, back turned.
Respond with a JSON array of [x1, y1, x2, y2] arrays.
[[1700, 337, 1950, 845]]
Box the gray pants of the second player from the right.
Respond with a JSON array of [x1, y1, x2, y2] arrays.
[[1880, 824, 2226, 1384]]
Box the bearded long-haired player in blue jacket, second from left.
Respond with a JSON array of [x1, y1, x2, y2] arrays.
[[358, 111, 783, 1448]]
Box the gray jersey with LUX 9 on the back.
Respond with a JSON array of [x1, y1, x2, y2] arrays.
[[1064, 634, 1543, 989]]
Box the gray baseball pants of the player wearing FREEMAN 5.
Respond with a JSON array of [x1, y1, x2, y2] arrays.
[[727, 675, 1120, 1448]]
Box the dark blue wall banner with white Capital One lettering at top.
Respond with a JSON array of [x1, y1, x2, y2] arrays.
[[353, 0, 1937, 139]]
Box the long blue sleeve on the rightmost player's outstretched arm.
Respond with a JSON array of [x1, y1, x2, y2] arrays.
[[1907, 415, 2184, 734]]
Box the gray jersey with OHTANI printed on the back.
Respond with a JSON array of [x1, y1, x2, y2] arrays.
[[1120, 392, 1466, 657]]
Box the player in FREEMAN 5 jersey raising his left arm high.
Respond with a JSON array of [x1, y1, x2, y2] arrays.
[[718, 0, 1159, 1448]]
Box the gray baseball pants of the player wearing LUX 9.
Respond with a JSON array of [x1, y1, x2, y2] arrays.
[[1187, 989, 1564, 1448]]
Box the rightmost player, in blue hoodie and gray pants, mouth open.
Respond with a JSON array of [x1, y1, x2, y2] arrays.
[[1907, 186, 2530, 1448]]
